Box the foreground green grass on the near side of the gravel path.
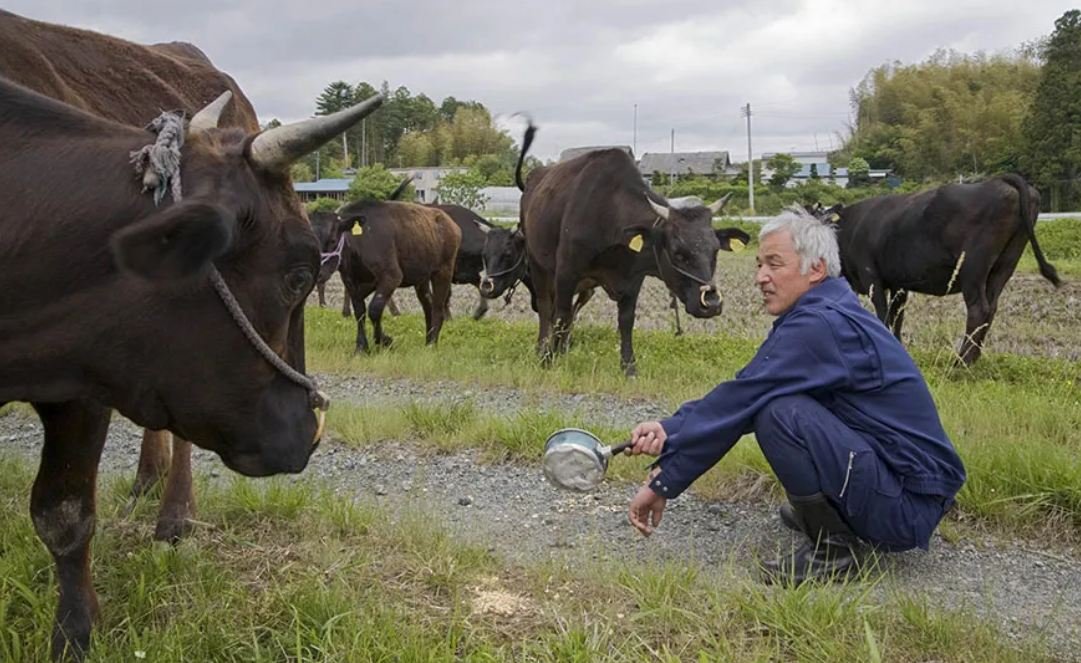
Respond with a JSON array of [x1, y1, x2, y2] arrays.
[[0, 458, 1053, 663]]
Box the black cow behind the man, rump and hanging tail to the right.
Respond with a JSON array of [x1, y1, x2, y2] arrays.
[[819, 174, 1062, 364]]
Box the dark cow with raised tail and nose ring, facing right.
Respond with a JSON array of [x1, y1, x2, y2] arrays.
[[510, 124, 748, 375]]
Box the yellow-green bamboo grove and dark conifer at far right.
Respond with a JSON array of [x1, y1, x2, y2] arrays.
[[836, 10, 1081, 210]]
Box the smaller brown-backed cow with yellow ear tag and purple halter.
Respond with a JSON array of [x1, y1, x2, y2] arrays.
[[335, 200, 462, 352]]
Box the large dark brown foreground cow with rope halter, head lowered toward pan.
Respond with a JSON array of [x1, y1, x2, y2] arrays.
[[0, 44, 382, 658]]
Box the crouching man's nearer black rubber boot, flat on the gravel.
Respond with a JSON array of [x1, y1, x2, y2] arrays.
[[762, 493, 864, 585]]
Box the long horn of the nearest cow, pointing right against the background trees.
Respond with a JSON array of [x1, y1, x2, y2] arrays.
[[252, 94, 384, 170]]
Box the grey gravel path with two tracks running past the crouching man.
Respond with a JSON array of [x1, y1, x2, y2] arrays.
[[0, 376, 1081, 661]]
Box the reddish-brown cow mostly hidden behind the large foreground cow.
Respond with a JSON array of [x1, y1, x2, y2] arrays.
[[0, 13, 259, 541]]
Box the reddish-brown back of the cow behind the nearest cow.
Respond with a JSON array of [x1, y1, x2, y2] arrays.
[[0, 13, 258, 132]]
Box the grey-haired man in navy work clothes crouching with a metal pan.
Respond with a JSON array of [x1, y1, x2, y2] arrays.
[[629, 209, 965, 583]]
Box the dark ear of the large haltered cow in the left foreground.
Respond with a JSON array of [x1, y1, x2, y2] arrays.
[[111, 202, 236, 280]]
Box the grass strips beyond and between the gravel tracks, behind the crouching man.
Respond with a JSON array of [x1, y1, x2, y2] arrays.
[[307, 309, 1081, 542]]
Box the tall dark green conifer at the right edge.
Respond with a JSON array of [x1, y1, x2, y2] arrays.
[[1022, 10, 1081, 210]]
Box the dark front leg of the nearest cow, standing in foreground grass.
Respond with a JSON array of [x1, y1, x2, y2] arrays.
[[30, 401, 109, 660]]
